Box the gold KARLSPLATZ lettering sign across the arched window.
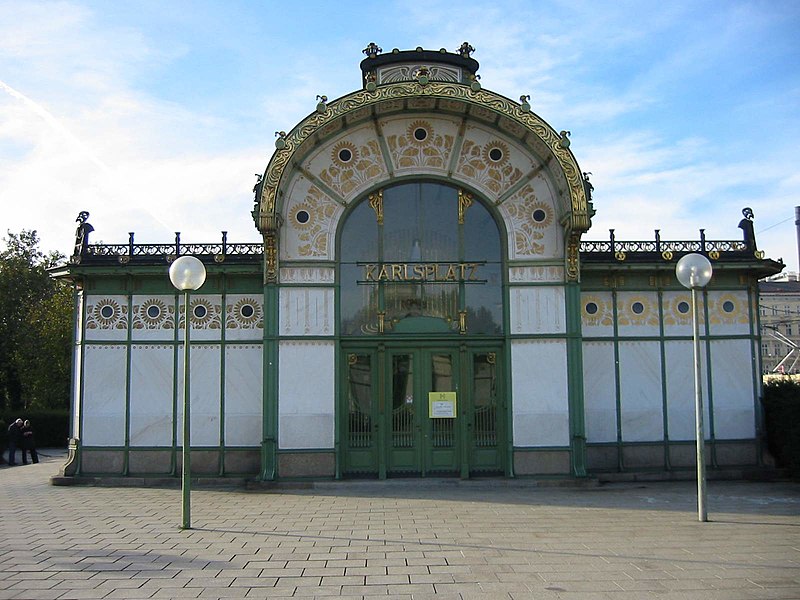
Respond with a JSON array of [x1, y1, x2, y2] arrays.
[[358, 262, 486, 283]]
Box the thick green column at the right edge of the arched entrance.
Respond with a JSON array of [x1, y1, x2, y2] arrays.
[[564, 282, 586, 477]]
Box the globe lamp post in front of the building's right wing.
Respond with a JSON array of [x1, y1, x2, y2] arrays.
[[675, 254, 713, 521]]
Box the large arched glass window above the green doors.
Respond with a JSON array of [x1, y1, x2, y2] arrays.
[[339, 182, 503, 336]]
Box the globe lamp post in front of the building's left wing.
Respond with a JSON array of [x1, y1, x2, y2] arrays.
[[169, 256, 206, 529]]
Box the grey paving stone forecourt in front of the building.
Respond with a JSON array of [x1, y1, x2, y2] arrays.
[[0, 456, 800, 600]]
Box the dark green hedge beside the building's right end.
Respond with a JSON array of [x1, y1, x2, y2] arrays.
[[763, 378, 800, 476]]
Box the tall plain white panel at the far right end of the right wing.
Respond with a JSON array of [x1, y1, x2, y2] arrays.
[[711, 339, 756, 440]]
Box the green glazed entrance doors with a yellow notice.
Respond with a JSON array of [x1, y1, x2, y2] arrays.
[[339, 346, 505, 477]]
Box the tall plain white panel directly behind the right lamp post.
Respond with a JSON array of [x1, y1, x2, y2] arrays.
[[664, 340, 709, 441]]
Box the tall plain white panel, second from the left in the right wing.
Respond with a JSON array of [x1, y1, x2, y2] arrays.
[[619, 342, 664, 442]]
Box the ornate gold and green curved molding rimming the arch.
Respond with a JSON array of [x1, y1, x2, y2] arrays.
[[253, 82, 591, 281]]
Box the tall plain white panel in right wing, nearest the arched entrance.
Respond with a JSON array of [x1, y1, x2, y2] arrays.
[[583, 342, 617, 442]]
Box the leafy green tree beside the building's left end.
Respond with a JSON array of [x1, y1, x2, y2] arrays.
[[0, 230, 73, 411]]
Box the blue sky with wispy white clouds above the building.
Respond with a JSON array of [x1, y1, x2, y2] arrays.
[[0, 0, 800, 271]]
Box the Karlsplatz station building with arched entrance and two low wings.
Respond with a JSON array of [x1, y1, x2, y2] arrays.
[[57, 43, 783, 480]]
